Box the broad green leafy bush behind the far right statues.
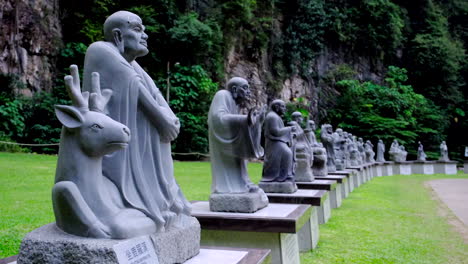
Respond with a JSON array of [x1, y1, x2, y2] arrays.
[[329, 66, 447, 148]]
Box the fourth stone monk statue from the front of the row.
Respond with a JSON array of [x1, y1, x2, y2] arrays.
[[288, 112, 314, 182]]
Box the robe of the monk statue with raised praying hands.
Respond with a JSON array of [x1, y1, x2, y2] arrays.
[[208, 90, 263, 193]]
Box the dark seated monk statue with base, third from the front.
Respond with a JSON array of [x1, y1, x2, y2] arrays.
[[259, 99, 298, 193]]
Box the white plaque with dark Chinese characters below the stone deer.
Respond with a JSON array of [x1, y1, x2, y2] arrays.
[[113, 236, 159, 264]]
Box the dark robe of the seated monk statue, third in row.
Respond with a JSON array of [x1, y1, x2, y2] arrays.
[[262, 111, 294, 182]]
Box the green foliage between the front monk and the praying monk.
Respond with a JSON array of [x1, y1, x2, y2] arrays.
[[160, 65, 218, 156]]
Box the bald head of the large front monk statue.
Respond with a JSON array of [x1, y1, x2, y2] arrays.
[[104, 11, 148, 62]]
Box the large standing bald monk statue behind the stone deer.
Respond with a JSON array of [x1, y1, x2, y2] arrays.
[[83, 11, 200, 262]]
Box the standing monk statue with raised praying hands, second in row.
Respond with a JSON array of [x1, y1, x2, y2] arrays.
[[208, 77, 268, 212]]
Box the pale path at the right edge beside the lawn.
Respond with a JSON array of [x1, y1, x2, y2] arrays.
[[427, 179, 468, 243]]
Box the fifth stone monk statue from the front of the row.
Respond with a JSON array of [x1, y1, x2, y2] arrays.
[[304, 120, 328, 176]]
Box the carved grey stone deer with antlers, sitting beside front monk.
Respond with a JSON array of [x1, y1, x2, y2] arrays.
[[52, 65, 156, 239]]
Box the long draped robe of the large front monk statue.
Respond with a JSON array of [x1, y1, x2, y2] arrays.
[[83, 41, 190, 229]]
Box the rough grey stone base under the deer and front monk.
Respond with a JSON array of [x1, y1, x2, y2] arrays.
[[18, 217, 200, 264]]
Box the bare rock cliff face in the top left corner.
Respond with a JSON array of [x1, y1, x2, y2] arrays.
[[0, 0, 62, 95]]
